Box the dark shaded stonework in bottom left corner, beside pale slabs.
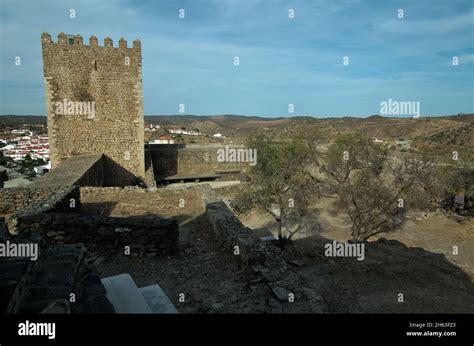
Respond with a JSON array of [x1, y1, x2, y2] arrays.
[[0, 241, 114, 314]]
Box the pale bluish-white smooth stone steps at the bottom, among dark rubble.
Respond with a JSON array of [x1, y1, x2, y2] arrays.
[[101, 274, 178, 314]]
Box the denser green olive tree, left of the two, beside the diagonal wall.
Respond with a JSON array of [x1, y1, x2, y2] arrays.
[[233, 133, 315, 246]]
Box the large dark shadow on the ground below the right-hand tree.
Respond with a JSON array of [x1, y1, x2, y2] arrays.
[[285, 235, 474, 313]]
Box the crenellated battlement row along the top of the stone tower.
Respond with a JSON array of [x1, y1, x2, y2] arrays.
[[41, 32, 142, 50]]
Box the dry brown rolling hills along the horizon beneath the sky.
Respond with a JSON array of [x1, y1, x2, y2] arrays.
[[0, 114, 474, 148]]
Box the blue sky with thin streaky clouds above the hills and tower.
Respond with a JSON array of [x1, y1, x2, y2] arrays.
[[0, 0, 474, 117]]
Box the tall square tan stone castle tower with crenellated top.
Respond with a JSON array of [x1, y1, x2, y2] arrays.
[[41, 33, 145, 186]]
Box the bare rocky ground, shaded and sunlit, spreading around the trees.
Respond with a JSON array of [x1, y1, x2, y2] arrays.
[[89, 187, 474, 313]]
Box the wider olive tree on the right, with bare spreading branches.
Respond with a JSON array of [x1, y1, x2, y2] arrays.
[[323, 134, 432, 241]]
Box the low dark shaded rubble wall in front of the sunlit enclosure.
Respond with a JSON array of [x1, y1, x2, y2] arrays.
[[9, 213, 179, 256]]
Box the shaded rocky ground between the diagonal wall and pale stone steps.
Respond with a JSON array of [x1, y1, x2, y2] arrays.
[[95, 214, 272, 313]]
